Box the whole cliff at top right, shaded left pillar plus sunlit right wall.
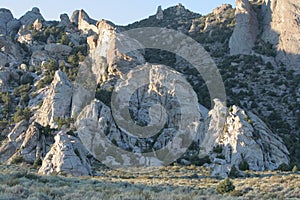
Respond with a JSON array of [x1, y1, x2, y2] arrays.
[[229, 0, 300, 71]]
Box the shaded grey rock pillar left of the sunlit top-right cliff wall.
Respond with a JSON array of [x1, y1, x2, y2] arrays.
[[229, 0, 259, 55]]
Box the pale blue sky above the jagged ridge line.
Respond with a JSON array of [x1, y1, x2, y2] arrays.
[[0, 0, 235, 25]]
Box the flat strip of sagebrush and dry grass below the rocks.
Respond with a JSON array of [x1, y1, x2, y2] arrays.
[[0, 165, 300, 200]]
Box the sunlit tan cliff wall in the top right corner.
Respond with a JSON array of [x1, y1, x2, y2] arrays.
[[261, 0, 300, 71]]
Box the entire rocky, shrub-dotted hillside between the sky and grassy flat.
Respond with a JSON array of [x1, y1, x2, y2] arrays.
[[0, 0, 300, 176]]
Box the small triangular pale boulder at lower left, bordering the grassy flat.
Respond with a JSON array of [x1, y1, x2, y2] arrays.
[[39, 131, 92, 176]]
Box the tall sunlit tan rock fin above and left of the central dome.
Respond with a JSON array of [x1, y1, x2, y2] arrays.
[[72, 20, 145, 116]]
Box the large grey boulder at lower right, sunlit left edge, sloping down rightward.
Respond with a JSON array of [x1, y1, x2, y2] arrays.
[[223, 106, 289, 170]]
